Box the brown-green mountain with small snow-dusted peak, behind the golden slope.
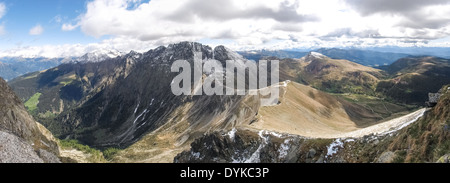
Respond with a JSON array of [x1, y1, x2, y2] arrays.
[[280, 52, 384, 95]]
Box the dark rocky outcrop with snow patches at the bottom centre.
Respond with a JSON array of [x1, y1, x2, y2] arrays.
[[174, 129, 316, 163]]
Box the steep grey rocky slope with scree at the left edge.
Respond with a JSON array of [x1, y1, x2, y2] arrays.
[[0, 78, 59, 163]]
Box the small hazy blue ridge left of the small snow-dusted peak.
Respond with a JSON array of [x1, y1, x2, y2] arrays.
[[238, 50, 308, 61]]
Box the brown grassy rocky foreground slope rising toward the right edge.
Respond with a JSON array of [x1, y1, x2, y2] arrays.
[[340, 85, 450, 163]]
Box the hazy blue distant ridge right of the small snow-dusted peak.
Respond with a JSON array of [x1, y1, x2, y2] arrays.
[[315, 48, 409, 67]]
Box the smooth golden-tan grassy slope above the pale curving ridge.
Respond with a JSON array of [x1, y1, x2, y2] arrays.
[[249, 82, 382, 138]]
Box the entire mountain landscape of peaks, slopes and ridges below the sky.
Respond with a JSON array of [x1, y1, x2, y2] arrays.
[[0, 42, 450, 162]]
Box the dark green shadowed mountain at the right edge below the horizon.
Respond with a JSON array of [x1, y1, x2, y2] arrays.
[[376, 56, 450, 105]]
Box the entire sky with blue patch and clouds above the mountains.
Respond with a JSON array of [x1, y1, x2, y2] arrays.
[[0, 0, 450, 57]]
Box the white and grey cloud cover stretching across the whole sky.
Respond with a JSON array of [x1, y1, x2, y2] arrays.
[[0, 0, 450, 56]]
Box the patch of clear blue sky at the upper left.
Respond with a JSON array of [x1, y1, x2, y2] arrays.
[[0, 0, 98, 49]]
